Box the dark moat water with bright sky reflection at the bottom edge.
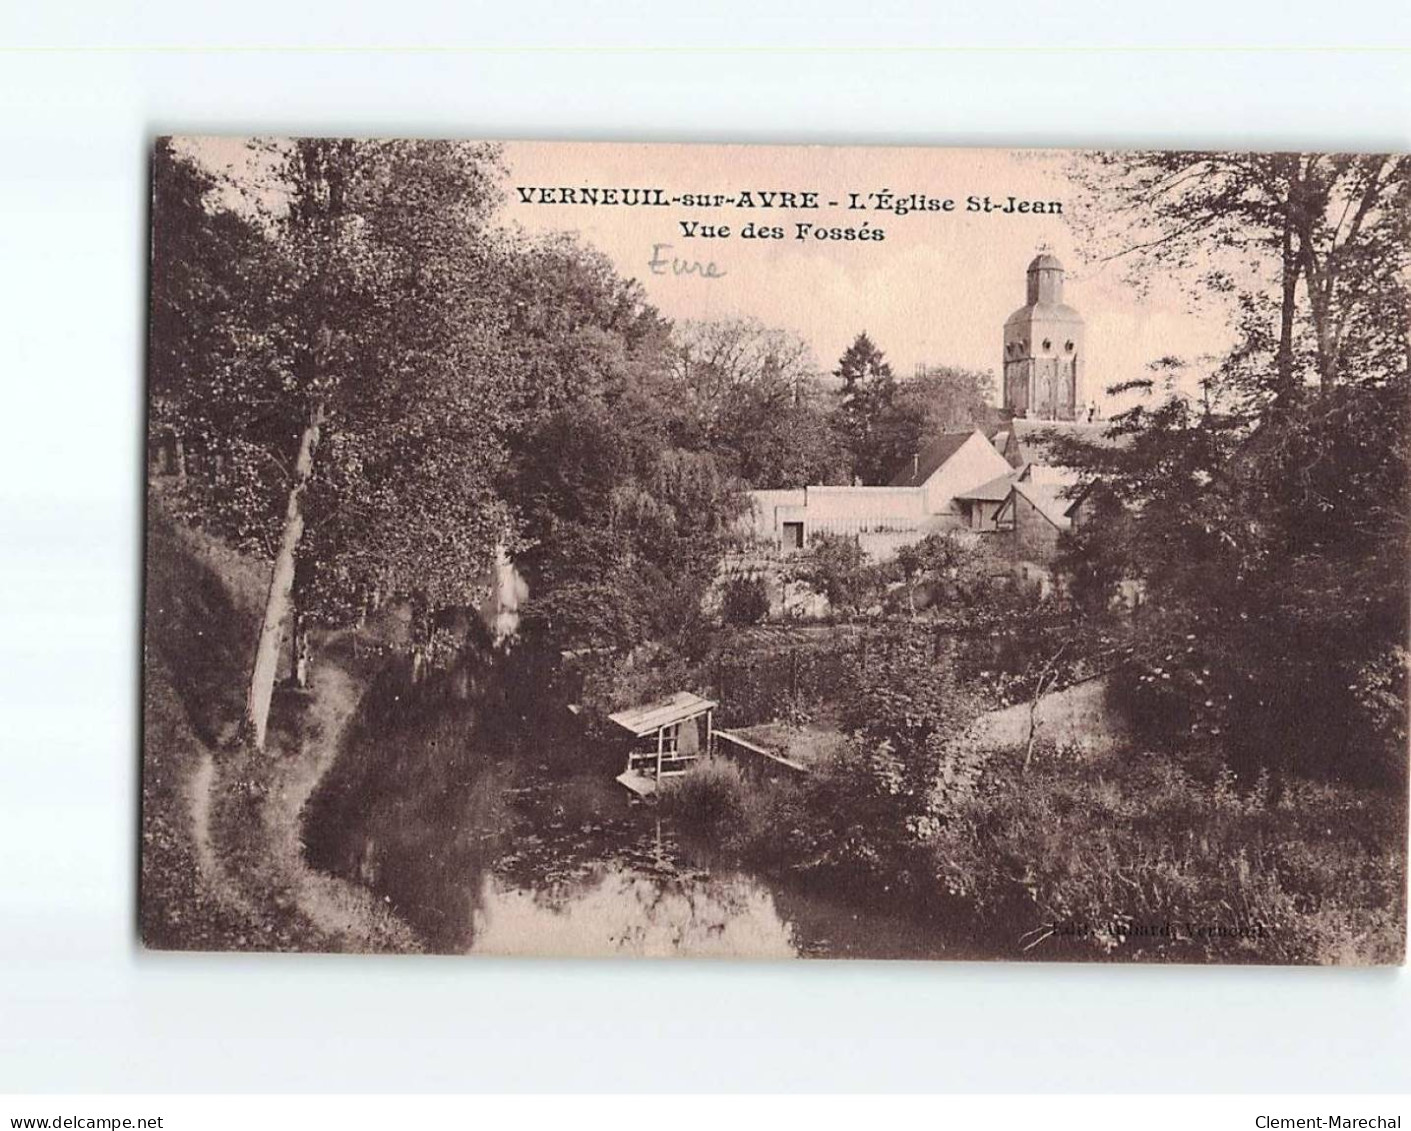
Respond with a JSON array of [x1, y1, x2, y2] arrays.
[[305, 648, 961, 959]]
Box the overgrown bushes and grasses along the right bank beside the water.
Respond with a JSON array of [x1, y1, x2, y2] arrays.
[[660, 626, 1407, 963]]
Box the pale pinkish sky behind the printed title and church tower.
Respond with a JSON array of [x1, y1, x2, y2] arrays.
[[183, 138, 1232, 415]]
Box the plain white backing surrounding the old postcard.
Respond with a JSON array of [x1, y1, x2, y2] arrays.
[[0, 0, 1411, 1092]]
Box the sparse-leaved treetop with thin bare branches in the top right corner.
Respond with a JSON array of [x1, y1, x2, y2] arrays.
[[1074, 151, 1411, 399]]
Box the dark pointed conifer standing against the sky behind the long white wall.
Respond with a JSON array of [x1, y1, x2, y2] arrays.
[[834, 331, 923, 485]]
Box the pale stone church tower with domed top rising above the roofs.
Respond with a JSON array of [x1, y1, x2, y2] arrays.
[[1005, 252, 1085, 420]]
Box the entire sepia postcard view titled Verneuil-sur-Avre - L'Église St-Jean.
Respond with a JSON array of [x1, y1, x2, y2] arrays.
[[138, 135, 1411, 966]]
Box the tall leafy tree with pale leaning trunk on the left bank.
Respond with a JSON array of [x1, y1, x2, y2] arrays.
[[248, 140, 519, 745]]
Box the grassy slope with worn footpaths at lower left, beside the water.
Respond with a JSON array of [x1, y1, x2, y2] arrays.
[[140, 505, 416, 950]]
